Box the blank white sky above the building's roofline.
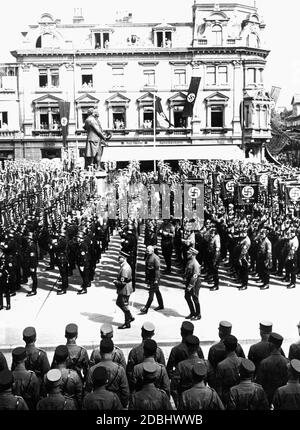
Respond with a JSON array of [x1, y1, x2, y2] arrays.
[[0, 0, 300, 108]]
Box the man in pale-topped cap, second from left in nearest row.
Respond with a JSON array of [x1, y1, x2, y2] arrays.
[[37, 369, 75, 411]]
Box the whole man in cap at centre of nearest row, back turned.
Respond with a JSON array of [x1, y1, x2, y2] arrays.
[[128, 362, 172, 411]]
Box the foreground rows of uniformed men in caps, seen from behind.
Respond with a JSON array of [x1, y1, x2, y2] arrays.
[[0, 321, 300, 411]]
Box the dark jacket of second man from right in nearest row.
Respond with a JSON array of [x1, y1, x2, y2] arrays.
[[228, 379, 269, 411]]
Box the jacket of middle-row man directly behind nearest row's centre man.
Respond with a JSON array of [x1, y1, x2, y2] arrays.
[[129, 357, 170, 396]]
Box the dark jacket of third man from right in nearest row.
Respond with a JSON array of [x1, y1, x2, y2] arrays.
[[178, 382, 225, 411]]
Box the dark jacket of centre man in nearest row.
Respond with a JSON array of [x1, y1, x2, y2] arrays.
[[128, 384, 172, 411]]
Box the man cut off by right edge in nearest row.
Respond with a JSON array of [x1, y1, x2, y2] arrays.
[[272, 359, 300, 411]]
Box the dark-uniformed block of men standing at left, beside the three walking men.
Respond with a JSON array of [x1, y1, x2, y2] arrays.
[[0, 211, 110, 310]]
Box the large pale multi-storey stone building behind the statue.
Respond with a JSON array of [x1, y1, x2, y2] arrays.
[[0, 1, 271, 161]]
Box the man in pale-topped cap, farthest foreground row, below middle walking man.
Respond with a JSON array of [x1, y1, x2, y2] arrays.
[[126, 321, 166, 380]]
